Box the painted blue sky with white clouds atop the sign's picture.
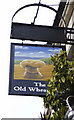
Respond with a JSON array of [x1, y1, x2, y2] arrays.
[[14, 45, 61, 60]]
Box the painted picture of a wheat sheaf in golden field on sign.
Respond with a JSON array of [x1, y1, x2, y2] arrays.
[[14, 45, 61, 81]]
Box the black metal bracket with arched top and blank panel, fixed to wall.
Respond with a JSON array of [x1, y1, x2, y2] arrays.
[[10, 3, 74, 45]]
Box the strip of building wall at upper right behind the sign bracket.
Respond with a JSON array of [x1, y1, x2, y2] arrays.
[[53, 0, 74, 60]]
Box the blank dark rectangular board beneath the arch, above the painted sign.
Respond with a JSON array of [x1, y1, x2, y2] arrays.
[[10, 22, 66, 43]]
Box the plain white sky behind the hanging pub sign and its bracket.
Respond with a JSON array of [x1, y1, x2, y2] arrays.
[[0, 0, 59, 119]]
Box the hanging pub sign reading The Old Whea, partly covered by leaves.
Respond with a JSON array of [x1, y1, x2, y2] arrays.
[[9, 43, 64, 96]]
